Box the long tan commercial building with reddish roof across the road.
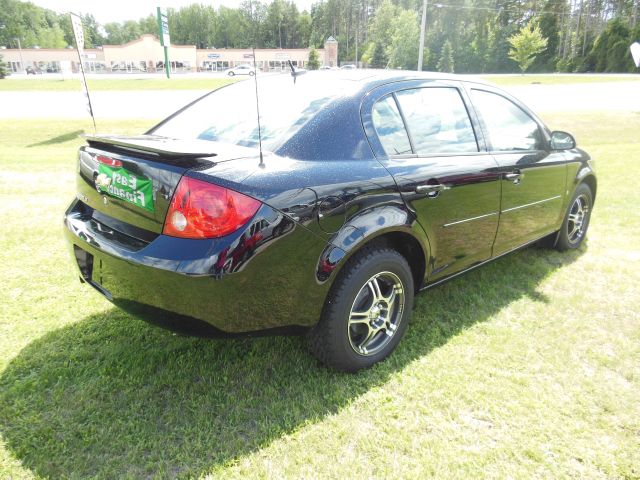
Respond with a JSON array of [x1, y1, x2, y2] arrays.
[[0, 35, 338, 73]]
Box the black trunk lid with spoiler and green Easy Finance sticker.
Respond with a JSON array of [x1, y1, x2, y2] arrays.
[[77, 135, 256, 235]]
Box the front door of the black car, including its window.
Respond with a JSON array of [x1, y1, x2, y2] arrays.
[[470, 87, 567, 255]]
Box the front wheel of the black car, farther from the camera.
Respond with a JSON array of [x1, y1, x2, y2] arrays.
[[556, 183, 593, 252]]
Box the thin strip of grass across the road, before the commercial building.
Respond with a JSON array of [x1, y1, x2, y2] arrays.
[[0, 77, 236, 92]]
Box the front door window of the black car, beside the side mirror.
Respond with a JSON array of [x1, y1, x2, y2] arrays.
[[471, 89, 543, 151]]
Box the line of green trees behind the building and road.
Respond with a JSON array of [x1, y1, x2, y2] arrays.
[[0, 0, 640, 73]]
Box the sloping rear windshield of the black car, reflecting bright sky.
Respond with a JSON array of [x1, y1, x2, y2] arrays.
[[152, 74, 356, 151]]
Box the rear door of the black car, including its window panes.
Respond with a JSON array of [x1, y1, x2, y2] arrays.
[[365, 82, 500, 281]]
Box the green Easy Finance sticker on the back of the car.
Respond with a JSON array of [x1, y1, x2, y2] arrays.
[[96, 163, 154, 212]]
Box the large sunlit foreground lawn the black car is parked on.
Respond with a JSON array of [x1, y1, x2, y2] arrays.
[[0, 112, 640, 479]]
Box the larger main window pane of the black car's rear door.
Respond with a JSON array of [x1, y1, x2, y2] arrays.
[[396, 87, 478, 155]]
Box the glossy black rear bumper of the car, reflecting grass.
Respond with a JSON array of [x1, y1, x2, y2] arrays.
[[64, 201, 328, 333]]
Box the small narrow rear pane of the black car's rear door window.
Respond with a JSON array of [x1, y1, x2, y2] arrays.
[[372, 95, 411, 155]]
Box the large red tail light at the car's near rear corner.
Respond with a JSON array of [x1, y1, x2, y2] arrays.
[[162, 177, 260, 238]]
